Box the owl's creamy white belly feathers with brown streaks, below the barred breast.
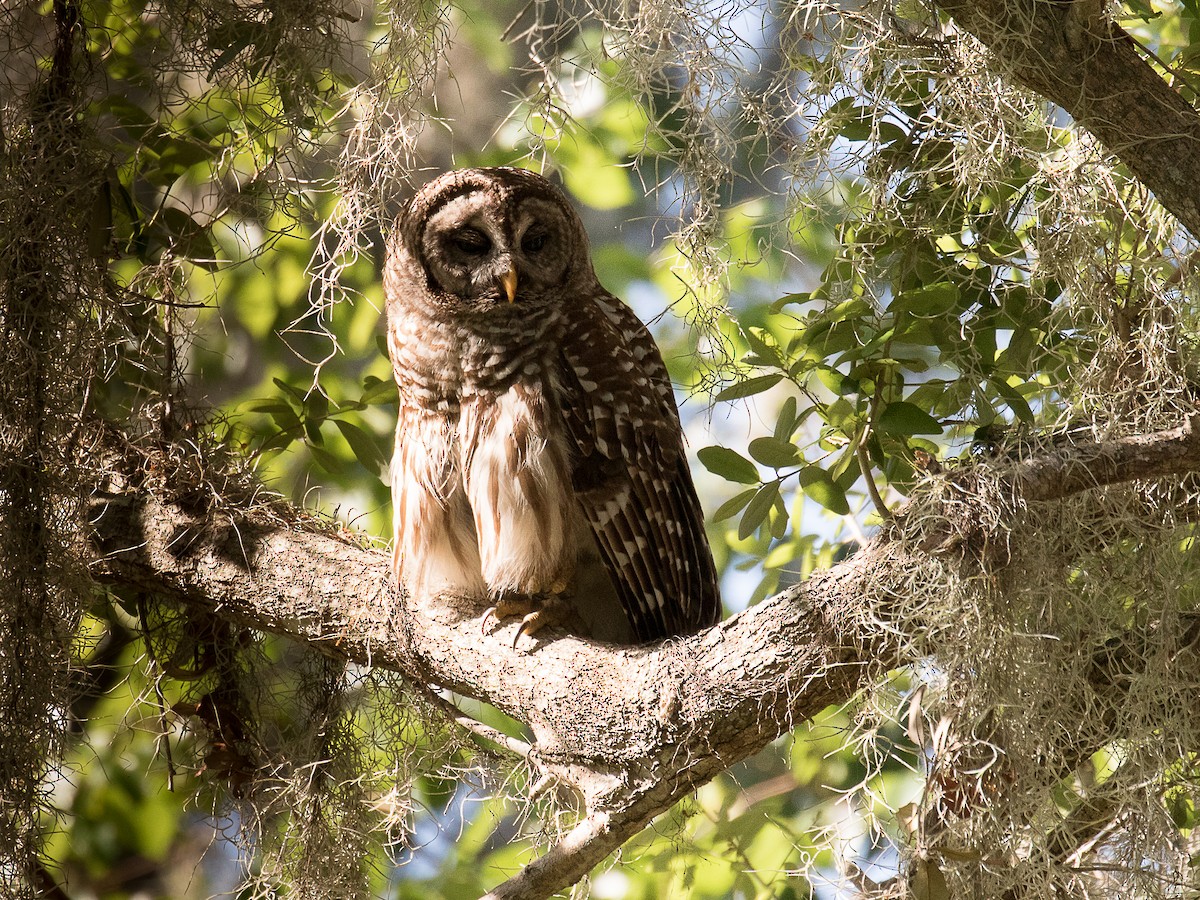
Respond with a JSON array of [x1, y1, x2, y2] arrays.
[[391, 383, 578, 599]]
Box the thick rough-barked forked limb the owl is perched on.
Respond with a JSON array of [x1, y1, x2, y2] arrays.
[[94, 425, 1200, 899]]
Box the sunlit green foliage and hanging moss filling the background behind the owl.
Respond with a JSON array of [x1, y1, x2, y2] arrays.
[[7, 0, 1200, 900]]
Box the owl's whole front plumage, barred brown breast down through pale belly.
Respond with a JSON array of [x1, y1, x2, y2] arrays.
[[389, 304, 587, 607]]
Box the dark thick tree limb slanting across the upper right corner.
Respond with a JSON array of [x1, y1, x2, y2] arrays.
[[936, 0, 1200, 236]]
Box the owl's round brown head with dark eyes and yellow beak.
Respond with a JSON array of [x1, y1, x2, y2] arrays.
[[395, 168, 595, 316]]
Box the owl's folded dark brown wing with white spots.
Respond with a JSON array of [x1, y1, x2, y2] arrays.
[[559, 292, 721, 641]]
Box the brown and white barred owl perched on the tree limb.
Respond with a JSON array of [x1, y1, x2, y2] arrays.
[[384, 168, 720, 641]]
